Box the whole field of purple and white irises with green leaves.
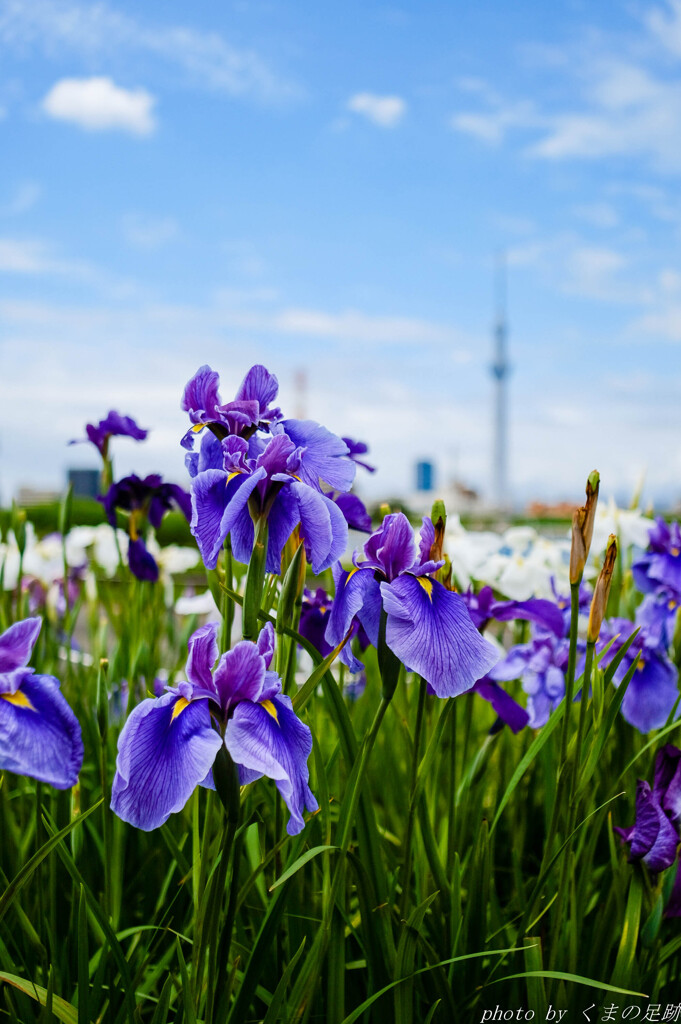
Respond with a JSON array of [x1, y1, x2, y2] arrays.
[[0, 366, 681, 1024]]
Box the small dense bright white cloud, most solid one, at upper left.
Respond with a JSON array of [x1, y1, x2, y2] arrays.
[[42, 78, 156, 135]]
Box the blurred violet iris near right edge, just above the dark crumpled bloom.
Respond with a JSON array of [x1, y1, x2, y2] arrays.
[[596, 618, 679, 732]]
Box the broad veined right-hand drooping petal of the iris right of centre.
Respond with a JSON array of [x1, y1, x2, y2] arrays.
[[381, 574, 499, 697]]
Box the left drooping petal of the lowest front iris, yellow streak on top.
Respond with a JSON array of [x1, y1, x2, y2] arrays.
[[112, 693, 222, 831]]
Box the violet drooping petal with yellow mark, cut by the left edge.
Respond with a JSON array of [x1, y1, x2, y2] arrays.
[[0, 676, 83, 790]]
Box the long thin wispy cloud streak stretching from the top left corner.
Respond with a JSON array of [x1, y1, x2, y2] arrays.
[[0, 0, 300, 101]]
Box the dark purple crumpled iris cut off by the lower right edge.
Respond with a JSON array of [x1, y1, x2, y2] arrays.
[[614, 743, 681, 872]]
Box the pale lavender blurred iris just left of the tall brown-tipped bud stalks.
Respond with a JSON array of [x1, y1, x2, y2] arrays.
[[488, 633, 569, 729]]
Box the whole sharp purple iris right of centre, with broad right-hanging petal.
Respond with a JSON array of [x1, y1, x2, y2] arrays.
[[326, 512, 498, 697]]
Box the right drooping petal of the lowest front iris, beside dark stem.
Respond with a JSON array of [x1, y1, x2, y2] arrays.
[[224, 694, 318, 836]]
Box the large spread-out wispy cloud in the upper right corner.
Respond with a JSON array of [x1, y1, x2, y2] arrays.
[[451, 7, 681, 173]]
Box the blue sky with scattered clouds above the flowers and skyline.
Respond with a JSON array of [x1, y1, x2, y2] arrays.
[[0, 0, 681, 503]]
